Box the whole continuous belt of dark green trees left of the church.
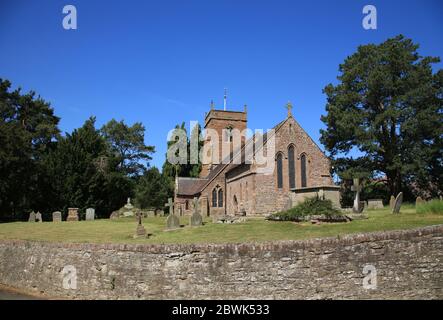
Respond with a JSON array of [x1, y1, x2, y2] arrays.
[[0, 79, 169, 221]]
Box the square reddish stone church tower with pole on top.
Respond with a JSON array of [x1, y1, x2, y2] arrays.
[[200, 99, 247, 178]]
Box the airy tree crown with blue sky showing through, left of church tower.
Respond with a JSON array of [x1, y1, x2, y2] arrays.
[[101, 119, 155, 176]]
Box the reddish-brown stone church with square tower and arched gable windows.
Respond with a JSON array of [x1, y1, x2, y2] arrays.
[[174, 103, 339, 216]]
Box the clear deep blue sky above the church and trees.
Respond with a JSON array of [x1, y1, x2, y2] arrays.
[[0, 0, 443, 167]]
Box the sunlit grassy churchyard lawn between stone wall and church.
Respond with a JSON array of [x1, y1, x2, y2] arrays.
[[0, 206, 443, 244]]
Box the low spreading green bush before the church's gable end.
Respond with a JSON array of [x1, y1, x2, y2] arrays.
[[268, 197, 342, 221]]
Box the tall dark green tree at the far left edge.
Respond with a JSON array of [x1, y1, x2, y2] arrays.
[[0, 79, 59, 220]]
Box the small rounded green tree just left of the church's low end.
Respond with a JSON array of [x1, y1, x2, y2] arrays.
[[135, 167, 169, 209]]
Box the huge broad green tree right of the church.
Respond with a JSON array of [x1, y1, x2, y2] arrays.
[[321, 35, 443, 194]]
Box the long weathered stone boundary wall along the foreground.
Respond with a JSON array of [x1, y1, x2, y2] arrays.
[[0, 225, 443, 299]]
